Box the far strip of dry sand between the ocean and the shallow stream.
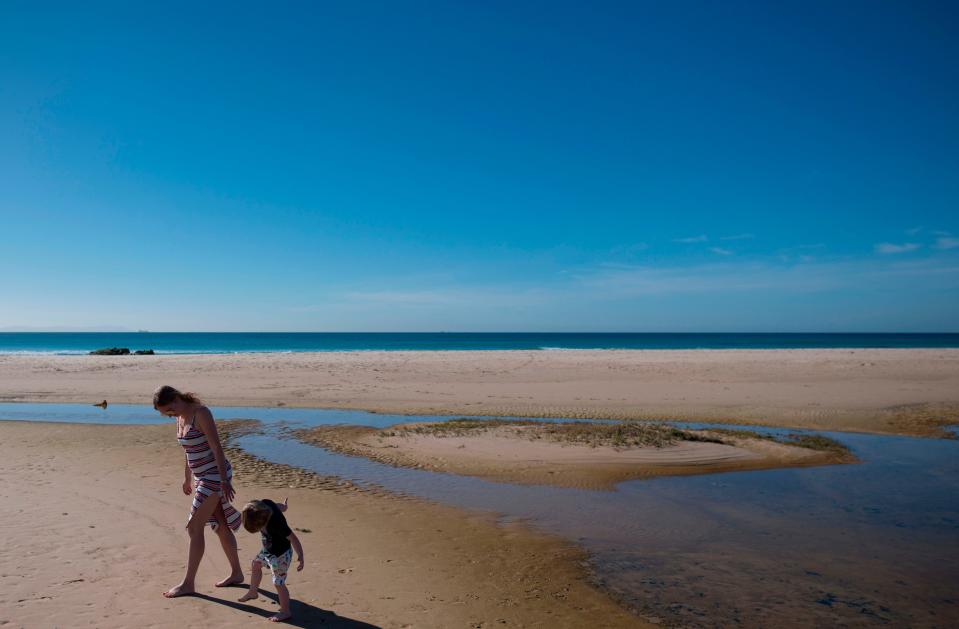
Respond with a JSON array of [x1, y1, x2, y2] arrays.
[[0, 349, 959, 436]]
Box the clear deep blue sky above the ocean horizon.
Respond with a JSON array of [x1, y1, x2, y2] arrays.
[[0, 2, 959, 331]]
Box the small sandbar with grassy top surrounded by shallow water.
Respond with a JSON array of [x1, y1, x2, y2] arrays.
[[295, 424, 855, 489]]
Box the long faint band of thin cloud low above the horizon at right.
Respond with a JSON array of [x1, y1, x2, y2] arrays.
[[295, 253, 959, 329]]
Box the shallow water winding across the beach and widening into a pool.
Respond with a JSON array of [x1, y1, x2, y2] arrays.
[[0, 404, 959, 627]]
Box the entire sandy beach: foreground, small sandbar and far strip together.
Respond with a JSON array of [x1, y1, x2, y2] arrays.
[[0, 350, 959, 627]]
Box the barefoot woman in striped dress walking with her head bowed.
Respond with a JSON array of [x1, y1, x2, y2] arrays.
[[153, 386, 243, 598]]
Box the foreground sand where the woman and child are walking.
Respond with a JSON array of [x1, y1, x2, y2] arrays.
[[0, 421, 645, 628]]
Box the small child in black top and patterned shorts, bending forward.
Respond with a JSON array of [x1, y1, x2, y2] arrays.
[[240, 499, 303, 622]]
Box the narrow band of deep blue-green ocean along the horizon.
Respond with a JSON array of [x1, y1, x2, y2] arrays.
[[0, 332, 959, 355]]
